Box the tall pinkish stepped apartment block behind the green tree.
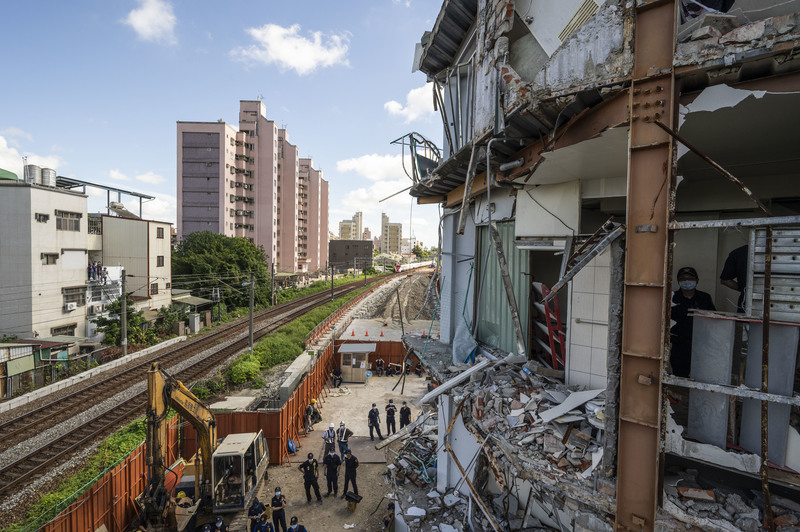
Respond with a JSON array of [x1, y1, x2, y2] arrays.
[[177, 101, 328, 273]]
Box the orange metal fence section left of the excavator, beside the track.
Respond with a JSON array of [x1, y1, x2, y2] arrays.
[[43, 416, 180, 532]]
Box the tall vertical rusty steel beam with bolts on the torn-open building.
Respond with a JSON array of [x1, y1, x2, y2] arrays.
[[615, 0, 677, 531]]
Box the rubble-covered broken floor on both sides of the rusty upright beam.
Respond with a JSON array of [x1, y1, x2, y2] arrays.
[[386, 336, 800, 531]]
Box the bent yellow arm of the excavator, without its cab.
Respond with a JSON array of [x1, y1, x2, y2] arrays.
[[145, 362, 217, 510]]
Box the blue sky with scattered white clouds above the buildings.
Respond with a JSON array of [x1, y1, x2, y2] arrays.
[[0, 0, 442, 246]]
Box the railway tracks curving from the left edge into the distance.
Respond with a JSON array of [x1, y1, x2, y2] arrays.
[[0, 282, 376, 497]]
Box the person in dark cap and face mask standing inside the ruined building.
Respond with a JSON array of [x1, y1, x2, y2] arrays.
[[669, 266, 717, 377]]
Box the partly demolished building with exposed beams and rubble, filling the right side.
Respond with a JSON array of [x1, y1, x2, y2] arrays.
[[400, 0, 800, 530]]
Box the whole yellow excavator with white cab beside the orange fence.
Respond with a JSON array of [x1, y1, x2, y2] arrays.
[[138, 362, 269, 531]]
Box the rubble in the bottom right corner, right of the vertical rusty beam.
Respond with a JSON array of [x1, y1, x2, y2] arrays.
[[664, 469, 800, 532]]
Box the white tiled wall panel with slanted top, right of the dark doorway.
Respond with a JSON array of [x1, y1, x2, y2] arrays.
[[567, 249, 611, 389]]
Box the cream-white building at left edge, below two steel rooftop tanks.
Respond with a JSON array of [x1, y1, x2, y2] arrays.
[[0, 180, 89, 338]]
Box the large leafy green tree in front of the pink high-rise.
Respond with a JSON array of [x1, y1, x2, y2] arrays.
[[172, 231, 270, 308]]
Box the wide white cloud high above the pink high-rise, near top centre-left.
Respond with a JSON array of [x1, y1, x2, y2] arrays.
[[231, 24, 350, 76]]
